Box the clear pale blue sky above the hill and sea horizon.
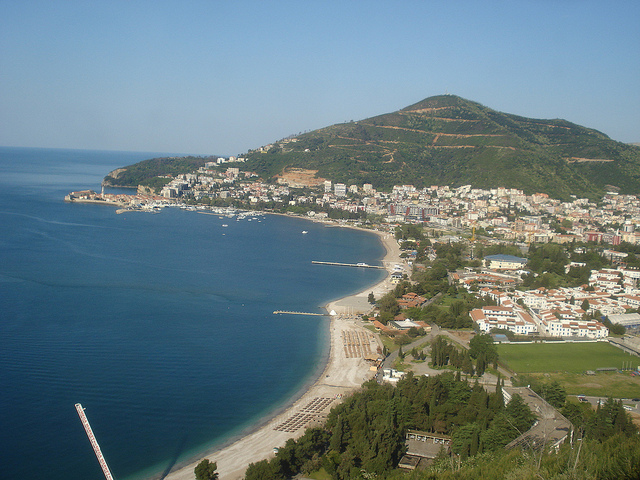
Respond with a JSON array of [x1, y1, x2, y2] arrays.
[[0, 0, 640, 155]]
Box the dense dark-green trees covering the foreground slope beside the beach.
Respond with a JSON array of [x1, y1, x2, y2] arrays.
[[245, 372, 640, 480]]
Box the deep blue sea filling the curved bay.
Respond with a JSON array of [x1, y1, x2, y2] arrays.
[[0, 147, 384, 480]]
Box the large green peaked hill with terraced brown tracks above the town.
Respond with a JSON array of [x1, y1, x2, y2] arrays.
[[248, 95, 640, 198]]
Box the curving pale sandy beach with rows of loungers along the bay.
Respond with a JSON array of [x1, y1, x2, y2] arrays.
[[160, 230, 402, 480]]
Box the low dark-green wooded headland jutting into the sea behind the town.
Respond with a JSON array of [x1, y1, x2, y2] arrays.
[[102, 156, 217, 187]]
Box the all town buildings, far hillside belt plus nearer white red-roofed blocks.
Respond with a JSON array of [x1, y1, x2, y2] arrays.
[[66, 157, 640, 346]]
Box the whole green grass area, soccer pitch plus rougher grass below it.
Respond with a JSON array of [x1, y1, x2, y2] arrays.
[[498, 342, 640, 398]]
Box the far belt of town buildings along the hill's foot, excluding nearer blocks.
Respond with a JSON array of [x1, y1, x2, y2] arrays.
[[70, 157, 640, 245]]
